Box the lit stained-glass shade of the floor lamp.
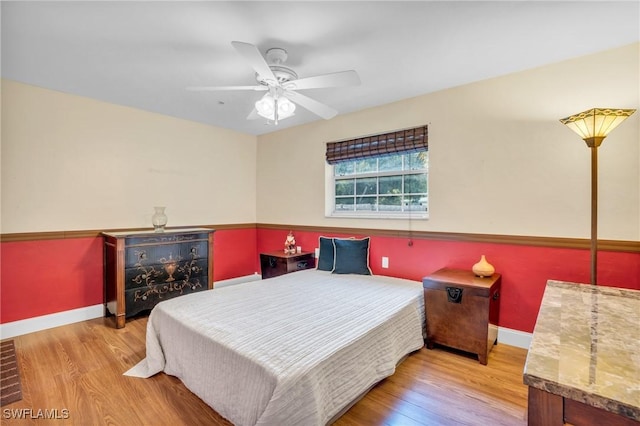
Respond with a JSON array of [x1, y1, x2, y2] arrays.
[[560, 108, 636, 146]]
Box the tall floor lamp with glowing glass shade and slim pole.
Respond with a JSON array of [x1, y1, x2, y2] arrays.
[[560, 108, 636, 285]]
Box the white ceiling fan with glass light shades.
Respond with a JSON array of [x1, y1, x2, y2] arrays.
[[187, 41, 360, 125]]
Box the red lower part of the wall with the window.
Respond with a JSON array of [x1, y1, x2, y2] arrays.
[[258, 229, 640, 333]]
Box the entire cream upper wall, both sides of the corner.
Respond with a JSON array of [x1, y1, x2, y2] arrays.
[[0, 44, 640, 240]]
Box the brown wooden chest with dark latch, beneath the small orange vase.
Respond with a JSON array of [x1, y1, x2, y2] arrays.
[[422, 268, 502, 365]]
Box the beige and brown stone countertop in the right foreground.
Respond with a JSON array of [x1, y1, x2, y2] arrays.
[[524, 280, 640, 420]]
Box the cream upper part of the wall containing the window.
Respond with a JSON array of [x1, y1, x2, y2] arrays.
[[257, 43, 640, 240]]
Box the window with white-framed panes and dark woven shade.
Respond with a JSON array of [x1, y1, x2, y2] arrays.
[[327, 126, 429, 218]]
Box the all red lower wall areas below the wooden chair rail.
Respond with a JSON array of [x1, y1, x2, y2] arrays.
[[0, 227, 640, 332]]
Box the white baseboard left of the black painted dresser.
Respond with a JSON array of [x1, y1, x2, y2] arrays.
[[0, 304, 104, 339]]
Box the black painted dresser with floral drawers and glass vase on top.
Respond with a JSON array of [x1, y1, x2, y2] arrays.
[[102, 228, 214, 328]]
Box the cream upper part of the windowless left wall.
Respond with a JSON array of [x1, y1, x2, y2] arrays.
[[1, 80, 256, 233]]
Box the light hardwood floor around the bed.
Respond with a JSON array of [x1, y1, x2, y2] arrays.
[[0, 317, 527, 426]]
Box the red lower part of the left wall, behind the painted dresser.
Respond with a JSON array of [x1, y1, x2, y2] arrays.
[[0, 228, 260, 324]]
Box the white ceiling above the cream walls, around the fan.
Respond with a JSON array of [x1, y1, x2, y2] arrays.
[[1, 0, 640, 135]]
